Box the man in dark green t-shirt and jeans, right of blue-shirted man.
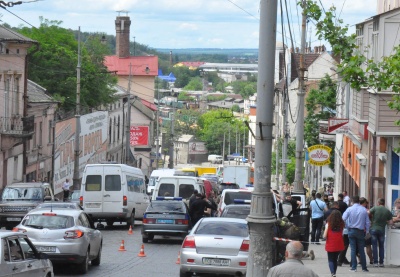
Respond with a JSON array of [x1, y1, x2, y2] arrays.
[[369, 198, 393, 267]]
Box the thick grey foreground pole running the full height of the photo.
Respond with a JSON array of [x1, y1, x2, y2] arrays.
[[247, 0, 277, 277]]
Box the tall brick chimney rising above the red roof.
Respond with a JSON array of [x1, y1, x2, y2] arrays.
[[115, 16, 131, 58]]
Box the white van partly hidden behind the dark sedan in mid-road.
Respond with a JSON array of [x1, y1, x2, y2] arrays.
[[151, 176, 205, 200]]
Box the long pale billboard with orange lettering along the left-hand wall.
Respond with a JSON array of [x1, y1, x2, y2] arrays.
[[54, 111, 108, 194]]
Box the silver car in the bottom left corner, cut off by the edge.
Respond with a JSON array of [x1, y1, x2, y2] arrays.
[[0, 230, 54, 277]]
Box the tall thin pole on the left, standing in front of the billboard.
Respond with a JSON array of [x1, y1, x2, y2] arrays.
[[72, 26, 81, 190]]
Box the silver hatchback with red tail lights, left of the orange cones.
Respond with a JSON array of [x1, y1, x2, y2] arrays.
[[16, 208, 103, 274]]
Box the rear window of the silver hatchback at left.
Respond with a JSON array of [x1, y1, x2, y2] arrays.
[[21, 214, 74, 229]]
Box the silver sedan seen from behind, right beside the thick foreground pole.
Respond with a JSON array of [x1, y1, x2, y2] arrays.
[[180, 217, 250, 277]]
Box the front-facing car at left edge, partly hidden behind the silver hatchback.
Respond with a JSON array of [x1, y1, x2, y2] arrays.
[[0, 183, 56, 230]]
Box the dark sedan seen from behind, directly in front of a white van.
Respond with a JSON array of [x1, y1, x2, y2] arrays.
[[142, 197, 191, 243]]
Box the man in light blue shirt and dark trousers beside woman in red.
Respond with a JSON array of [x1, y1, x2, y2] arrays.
[[342, 195, 371, 272]]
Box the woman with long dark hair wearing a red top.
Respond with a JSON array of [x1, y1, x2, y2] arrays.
[[324, 210, 345, 277]]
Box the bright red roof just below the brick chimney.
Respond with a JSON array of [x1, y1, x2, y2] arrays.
[[104, 56, 158, 76]]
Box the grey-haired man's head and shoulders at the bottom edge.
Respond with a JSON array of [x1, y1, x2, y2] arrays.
[[267, 241, 318, 277]]
